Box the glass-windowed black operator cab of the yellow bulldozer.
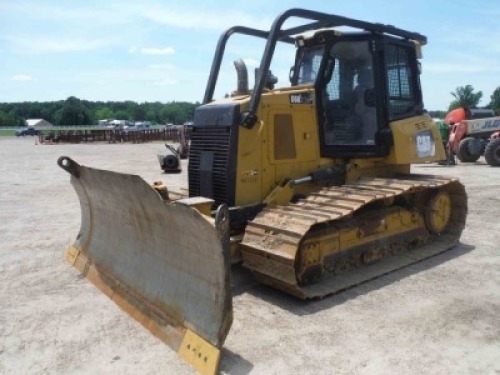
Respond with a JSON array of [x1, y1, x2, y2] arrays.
[[291, 30, 423, 157]]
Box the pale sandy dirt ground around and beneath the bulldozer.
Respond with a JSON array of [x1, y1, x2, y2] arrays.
[[0, 137, 500, 375]]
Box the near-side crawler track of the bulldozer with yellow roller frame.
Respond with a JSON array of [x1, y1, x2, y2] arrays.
[[242, 175, 467, 298]]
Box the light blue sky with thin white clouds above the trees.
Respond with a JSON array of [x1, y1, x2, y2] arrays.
[[0, 0, 500, 110]]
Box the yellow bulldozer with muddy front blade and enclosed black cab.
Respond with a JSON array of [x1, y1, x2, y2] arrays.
[[58, 9, 467, 374]]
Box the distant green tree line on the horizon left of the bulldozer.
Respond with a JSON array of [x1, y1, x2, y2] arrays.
[[0, 96, 200, 126]]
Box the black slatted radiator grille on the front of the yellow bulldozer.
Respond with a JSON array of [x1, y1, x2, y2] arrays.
[[189, 125, 234, 206]]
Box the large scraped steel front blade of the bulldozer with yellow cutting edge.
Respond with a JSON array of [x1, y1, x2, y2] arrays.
[[58, 157, 232, 374]]
